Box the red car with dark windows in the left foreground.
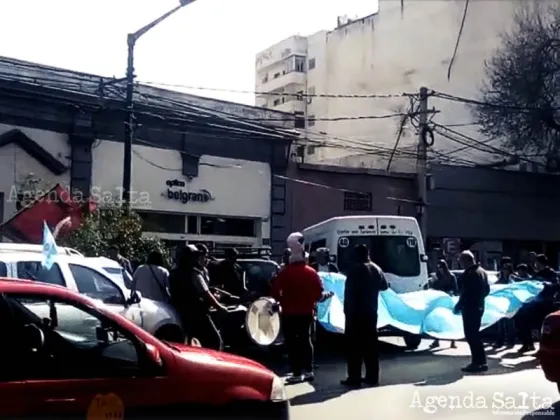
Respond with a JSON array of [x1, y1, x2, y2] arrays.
[[0, 279, 289, 419]]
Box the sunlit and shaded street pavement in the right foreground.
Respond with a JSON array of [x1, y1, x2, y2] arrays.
[[288, 339, 560, 420]]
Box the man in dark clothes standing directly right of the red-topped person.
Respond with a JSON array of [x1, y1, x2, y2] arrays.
[[341, 245, 389, 387]]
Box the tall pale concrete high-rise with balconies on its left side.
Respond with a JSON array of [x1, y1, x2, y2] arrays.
[[255, 0, 548, 172]]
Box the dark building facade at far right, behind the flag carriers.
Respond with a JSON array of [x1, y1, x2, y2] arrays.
[[427, 165, 560, 268]]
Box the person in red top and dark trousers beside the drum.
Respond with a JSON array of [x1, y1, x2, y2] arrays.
[[271, 234, 331, 383]]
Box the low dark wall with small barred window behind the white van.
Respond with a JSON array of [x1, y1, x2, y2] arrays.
[[287, 164, 417, 231]]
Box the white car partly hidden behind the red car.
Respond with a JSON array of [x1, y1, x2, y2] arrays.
[[0, 250, 183, 342]]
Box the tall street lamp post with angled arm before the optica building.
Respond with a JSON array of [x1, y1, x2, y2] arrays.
[[123, 0, 195, 203]]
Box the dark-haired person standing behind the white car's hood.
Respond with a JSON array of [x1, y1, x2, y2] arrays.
[[132, 251, 170, 303]]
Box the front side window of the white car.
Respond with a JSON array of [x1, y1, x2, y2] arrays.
[[69, 264, 125, 305]]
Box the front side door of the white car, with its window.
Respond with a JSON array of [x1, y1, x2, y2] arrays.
[[68, 263, 144, 328]]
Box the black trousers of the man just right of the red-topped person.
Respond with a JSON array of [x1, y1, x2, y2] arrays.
[[344, 315, 379, 382]]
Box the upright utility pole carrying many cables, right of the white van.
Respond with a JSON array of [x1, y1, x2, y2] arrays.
[[416, 87, 428, 246]]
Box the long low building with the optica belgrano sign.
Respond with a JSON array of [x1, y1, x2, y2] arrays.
[[0, 58, 294, 253]]
